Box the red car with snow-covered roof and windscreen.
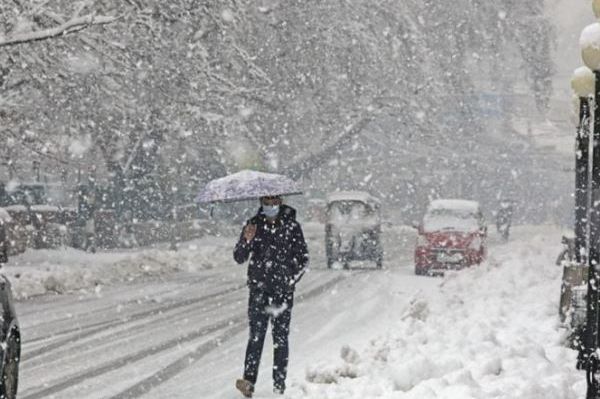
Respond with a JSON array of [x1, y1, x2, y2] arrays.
[[415, 199, 487, 275]]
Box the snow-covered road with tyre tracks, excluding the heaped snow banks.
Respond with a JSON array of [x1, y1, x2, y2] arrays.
[[17, 226, 428, 399]]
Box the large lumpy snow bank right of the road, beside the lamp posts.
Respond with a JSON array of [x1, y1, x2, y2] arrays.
[[289, 227, 585, 399]]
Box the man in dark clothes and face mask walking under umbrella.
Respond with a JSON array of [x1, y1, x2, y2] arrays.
[[233, 196, 308, 398]]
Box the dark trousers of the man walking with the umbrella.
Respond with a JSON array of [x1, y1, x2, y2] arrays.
[[244, 288, 294, 389]]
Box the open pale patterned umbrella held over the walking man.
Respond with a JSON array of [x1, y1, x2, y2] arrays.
[[198, 170, 302, 203]]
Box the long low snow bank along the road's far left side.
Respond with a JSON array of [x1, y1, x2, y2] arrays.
[[2, 237, 235, 300]]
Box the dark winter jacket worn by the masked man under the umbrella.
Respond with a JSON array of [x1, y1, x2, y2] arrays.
[[233, 205, 308, 294]]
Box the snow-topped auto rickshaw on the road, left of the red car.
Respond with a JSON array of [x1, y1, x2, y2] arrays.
[[325, 191, 383, 269]]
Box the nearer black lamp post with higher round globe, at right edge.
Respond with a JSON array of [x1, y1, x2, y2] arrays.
[[579, 19, 600, 399]]
